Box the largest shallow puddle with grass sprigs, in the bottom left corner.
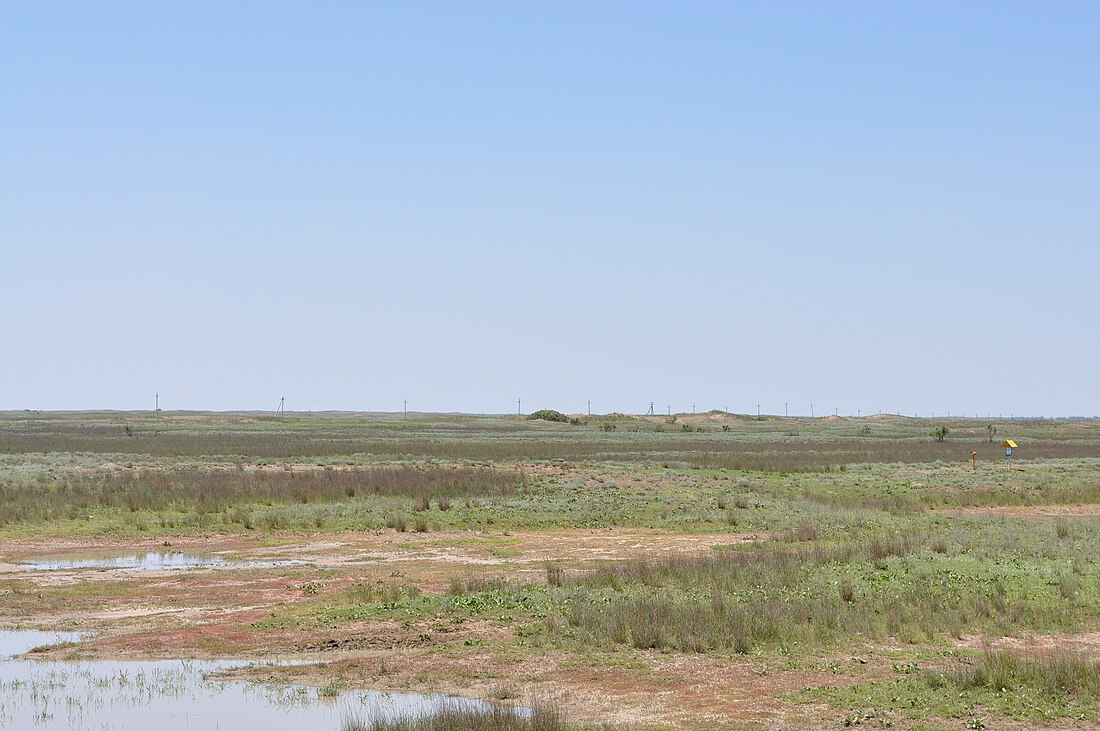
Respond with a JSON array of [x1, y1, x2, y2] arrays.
[[0, 631, 506, 731]]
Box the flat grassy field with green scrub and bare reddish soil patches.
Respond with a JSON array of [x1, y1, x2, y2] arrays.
[[0, 412, 1100, 729]]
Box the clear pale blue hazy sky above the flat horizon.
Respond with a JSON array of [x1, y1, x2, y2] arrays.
[[0, 0, 1100, 416]]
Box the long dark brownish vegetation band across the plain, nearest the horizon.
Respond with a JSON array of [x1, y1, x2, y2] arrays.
[[0, 425, 1100, 472]]
